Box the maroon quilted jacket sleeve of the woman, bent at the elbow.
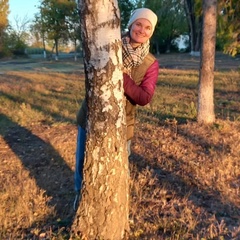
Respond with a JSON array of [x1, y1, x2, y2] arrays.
[[123, 60, 159, 106]]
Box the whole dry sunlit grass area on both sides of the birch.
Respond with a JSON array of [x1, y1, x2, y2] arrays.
[[0, 57, 240, 240]]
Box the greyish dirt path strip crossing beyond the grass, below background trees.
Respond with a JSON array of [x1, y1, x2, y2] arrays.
[[0, 52, 240, 72]]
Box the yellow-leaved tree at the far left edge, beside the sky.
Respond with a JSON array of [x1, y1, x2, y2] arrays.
[[0, 0, 9, 57]]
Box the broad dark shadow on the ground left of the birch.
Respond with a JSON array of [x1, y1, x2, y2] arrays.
[[0, 114, 75, 236]]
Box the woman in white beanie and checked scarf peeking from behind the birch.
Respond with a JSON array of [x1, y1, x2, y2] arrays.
[[74, 8, 159, 210]]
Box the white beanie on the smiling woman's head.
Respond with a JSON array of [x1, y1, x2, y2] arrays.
[[128, 8, 157, 32]]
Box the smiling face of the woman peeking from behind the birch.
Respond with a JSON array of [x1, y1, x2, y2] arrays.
[[130, 18, 152, 47]]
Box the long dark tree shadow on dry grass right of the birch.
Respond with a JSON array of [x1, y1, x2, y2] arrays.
[[130, 152, 240, 240]]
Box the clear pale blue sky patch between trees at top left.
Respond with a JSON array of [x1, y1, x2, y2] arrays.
[[8, 0, 40, 25]]
